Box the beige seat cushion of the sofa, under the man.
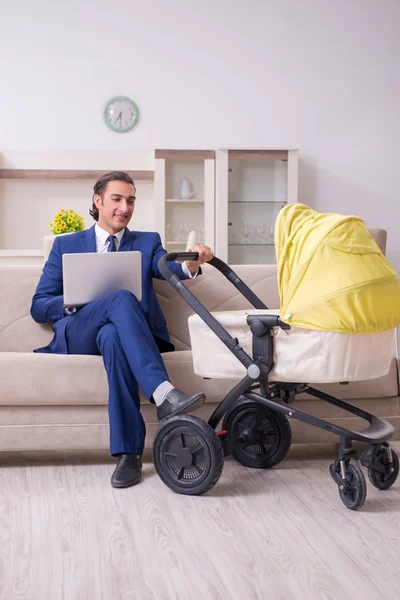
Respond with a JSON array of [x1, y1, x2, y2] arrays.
[[0, 350, 398, 406]]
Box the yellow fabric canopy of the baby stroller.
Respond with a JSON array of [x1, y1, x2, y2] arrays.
[[275, 203, 400, 333]]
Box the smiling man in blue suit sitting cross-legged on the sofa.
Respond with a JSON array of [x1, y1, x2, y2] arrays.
[[31, 171, 213, 487]]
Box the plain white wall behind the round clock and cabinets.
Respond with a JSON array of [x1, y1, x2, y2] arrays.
[[0, 0, 400, 268]]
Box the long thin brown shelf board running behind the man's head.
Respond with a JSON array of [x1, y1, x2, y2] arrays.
[[0, 169, 154, 181]]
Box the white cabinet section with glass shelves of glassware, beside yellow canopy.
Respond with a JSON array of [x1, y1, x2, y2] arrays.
[[215, 149, 298, 265]]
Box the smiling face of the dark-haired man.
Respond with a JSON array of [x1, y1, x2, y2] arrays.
[[94, 181, 136, 235]]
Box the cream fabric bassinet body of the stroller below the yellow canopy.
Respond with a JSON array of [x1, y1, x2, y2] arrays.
[[189, 309, 396, 383]]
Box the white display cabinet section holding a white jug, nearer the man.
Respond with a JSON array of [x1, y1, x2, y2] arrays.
[[154, 150, 215, 252]]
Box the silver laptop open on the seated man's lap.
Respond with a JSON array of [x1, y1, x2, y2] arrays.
[[62, 251, 142, 308]]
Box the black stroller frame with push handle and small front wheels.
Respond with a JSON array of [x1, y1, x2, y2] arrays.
[[155, 252, 399, 510]]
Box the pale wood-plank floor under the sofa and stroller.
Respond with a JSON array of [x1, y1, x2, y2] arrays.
[[0, 448, 400, 600]]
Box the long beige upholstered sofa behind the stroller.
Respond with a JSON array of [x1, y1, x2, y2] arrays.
[[0, 230, 400, 451]]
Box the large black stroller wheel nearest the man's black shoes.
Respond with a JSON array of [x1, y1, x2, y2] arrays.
[[153, 415, 224, 496]]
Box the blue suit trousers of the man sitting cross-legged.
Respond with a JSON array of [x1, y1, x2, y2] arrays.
[[65, 290, 169, 455]]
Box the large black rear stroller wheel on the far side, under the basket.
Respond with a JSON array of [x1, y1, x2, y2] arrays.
[[222, 398, 292, 469]]
